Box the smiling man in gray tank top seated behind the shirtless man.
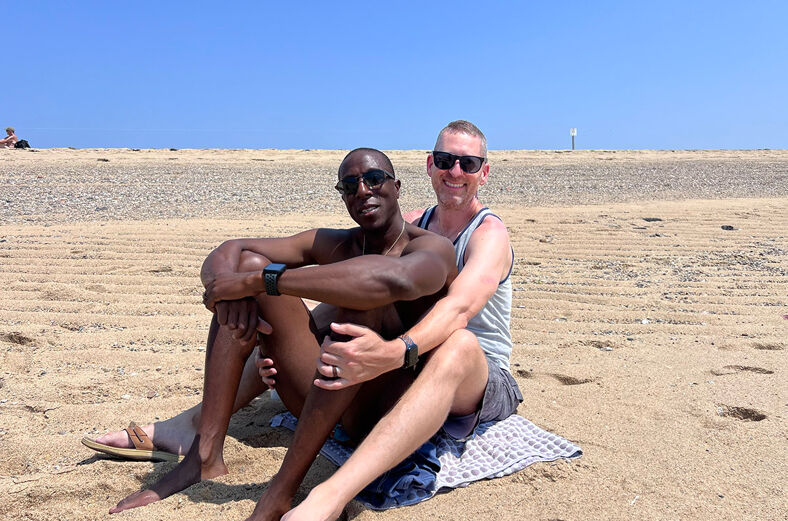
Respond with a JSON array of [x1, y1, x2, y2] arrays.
[[83, 121, 522, 519]]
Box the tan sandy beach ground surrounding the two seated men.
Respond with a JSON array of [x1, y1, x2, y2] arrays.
[[0, 149, 788, 521]]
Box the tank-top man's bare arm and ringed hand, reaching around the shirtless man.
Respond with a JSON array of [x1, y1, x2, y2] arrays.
[[317, 217, 511, 389]]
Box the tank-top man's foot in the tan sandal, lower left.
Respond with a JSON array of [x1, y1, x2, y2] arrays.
[[96, 405, 200, 455]]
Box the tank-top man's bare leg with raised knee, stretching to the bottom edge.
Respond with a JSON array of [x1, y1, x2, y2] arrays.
[[282, 329, 487, 521]]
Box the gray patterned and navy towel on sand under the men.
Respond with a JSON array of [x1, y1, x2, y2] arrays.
[[271, 412, 583, 510]]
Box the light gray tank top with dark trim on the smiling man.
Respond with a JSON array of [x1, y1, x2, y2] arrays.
[[417, 206, 514, 371]]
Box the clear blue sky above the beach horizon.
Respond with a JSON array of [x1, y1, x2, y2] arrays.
[[6, 0, 788, 149]]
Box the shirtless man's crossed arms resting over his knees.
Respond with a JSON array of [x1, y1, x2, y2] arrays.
[[200, 229, 456, 320]]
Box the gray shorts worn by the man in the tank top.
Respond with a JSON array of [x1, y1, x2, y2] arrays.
[[443, 358, 523, 441]]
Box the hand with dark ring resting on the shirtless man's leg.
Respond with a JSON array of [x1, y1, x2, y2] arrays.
[[314, 322, 405, 391]]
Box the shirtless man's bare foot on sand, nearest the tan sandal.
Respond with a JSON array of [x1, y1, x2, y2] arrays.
[[109, 436, 227, 514]]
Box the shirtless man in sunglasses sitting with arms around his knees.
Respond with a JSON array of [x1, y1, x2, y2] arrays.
[[110, 145, 458, 519]]
